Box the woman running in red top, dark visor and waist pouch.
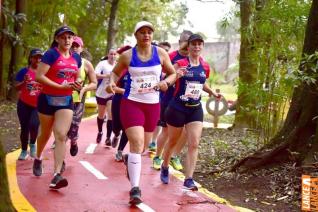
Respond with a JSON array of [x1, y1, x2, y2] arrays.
[[33, 26, 81, 189]]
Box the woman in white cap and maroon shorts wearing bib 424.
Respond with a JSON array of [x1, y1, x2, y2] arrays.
[[107, 21, 176, 205]]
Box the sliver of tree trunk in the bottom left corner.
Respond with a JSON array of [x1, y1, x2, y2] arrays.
[[0, 141, 16, 212]]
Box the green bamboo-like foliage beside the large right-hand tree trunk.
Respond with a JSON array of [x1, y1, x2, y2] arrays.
[[234, 0, 310, 142]]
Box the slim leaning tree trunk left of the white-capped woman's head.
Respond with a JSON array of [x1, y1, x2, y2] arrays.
[[106, 0, 119, 55]]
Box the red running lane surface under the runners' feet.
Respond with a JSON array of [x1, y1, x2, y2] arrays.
[[13, 118, 240, 212]]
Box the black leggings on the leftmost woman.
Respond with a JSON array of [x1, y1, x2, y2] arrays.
[[17, 100, 40, 150]]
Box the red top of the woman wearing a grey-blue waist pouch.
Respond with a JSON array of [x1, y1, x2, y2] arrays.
[[42, 48, 78, 96]]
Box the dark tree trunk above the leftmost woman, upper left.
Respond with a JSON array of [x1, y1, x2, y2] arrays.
[[7, 0, 26, 100]]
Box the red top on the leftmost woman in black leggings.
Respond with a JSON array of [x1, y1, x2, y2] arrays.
[[20, 68, 42, 107]]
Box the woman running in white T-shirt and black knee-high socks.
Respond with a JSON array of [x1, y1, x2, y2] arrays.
[[95, 49, 117, 146]]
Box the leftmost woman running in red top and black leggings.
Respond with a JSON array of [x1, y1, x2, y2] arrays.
[[15, 49, 43, 160]]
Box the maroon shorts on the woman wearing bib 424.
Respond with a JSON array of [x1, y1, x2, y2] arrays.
[[120, 98, 160, 132]]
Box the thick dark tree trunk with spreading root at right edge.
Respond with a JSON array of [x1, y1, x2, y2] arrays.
[[232, 0, 318, 171]]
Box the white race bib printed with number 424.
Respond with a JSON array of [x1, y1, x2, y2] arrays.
[[131, 75, 158, 94]]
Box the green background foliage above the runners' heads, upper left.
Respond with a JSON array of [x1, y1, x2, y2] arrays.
[[1, 0, 188, 91]]
